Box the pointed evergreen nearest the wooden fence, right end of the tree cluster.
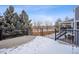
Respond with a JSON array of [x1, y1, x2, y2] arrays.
[[20, 10, 32, 34]]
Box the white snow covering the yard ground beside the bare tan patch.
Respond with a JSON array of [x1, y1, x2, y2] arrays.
[[0, 36, 79, 54]]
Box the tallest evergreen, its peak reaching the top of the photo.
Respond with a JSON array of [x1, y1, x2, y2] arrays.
[[4, 6, 14, 32]]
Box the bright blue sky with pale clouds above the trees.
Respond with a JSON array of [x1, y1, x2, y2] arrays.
[[0, 5, 76, 24]]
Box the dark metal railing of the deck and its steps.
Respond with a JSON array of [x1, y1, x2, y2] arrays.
[[55, 29, 79, 46]]
